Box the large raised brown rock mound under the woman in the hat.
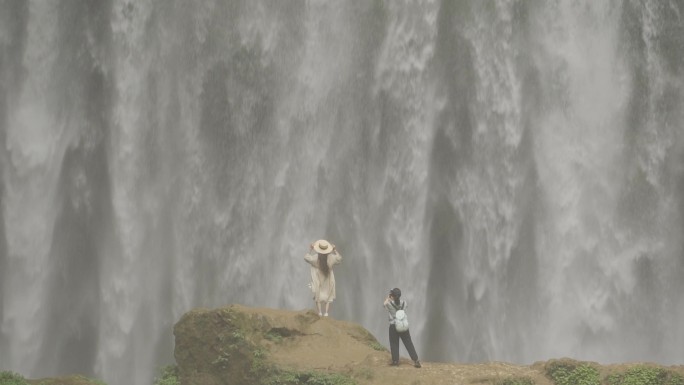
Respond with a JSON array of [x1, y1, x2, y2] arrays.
[[174, 305, 387, 385]]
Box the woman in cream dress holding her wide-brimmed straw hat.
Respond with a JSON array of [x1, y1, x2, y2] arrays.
[[304, 239, 342, 317]]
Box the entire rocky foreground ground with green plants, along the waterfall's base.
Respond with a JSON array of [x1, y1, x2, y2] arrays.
[[5, 305, 684, 385]]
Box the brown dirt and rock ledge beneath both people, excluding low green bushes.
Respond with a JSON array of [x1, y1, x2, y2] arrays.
[[174, 305, 684, 385]]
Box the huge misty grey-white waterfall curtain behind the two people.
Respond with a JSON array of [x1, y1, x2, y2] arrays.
[[0, 0, 684, 384]]
